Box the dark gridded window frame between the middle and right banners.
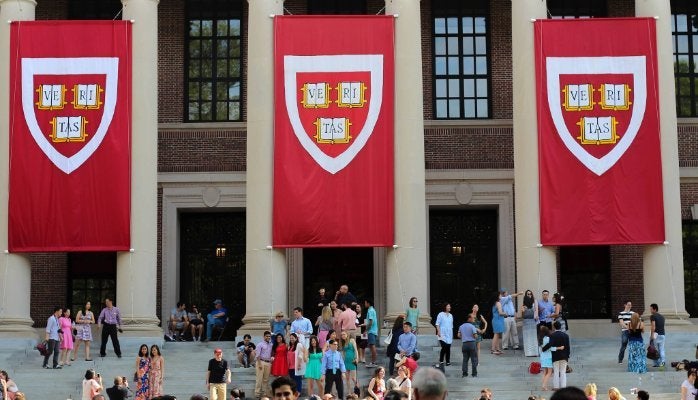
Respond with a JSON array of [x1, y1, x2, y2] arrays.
[[431, 0, 493, 120]]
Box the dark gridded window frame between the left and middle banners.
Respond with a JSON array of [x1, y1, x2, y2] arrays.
[[183, 0, 244, 123]]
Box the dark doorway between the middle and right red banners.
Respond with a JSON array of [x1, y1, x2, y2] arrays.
[[429, 209, 499, 336]]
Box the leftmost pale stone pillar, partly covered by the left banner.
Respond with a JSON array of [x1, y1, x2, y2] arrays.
[[0, 0, 36, 340]]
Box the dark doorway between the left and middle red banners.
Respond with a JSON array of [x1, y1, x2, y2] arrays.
[[179, 212, 245, 339]]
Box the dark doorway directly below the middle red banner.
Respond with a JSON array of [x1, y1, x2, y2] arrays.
[[303, 247, 373, 323]]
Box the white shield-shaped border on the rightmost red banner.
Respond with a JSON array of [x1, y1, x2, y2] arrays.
[[545, 56, 647, 176]]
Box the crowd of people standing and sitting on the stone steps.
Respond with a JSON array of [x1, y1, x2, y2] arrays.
[[14, 285, 696, 400]]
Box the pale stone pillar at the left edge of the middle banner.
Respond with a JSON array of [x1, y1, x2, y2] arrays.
[[239, 0, 286, 335]]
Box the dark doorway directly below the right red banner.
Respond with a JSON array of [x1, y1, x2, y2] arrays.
[[560, 246, 613, 319]]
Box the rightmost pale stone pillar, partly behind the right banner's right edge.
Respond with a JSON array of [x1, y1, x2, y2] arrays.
[[635, 0, 688, 322]]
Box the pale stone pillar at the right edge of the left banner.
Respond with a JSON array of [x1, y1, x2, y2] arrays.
[[116, 0, 162, 338]]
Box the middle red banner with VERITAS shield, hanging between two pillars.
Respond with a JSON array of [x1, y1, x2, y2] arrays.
[[272, 16, 394, 247]]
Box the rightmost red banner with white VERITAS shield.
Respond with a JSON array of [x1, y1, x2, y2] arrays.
[[535, 18, 664, 245]]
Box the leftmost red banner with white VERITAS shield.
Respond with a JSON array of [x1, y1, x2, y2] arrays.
[[8, 21, 131, 252]]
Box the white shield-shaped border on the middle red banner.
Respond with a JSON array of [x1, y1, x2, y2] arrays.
[[284, 54, 383, 174]]
